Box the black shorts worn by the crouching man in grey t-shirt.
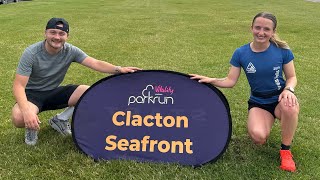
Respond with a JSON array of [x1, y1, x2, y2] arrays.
[[26, 84, 79, 112]]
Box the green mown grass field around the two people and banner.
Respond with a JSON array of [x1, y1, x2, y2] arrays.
[[0, 0, 320, 179]]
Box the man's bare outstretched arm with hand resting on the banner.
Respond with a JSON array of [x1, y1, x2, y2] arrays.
[[81, 56, 141, 74]]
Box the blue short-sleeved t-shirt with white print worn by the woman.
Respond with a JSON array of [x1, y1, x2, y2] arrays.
[[230, 43, 294, 104]]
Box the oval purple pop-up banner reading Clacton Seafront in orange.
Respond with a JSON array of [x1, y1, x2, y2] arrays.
[[72, 70, 232, 166]]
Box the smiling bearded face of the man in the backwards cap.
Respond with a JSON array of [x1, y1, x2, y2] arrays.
[[45, 24, 68, 49]]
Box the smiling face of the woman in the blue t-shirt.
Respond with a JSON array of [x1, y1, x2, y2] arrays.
[[251, 17, 275, 44]]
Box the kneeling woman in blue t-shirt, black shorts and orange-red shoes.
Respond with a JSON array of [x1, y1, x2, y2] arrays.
[[191, 12, 299, 172]]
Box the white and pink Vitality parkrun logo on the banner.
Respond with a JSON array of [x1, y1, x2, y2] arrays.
[[128, 84, 174, 106]]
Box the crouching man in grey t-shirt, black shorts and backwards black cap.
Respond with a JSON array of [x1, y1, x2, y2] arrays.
[[12, 18, 140, 145]]
